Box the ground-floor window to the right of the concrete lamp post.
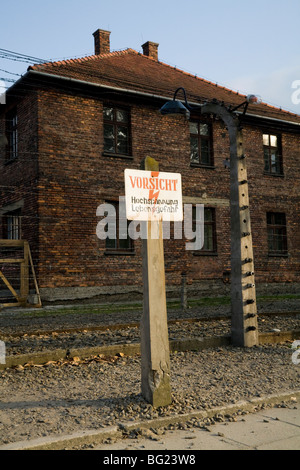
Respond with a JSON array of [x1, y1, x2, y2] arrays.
[[267, 212, 287, 255]]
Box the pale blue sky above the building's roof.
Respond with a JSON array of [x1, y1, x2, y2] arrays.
[[0, 0, 300, 114]]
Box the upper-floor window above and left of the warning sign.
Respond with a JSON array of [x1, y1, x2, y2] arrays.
[[103, 107, 131, 156]]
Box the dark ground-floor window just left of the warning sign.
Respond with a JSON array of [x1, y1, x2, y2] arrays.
[[105, 201, 133, 254]]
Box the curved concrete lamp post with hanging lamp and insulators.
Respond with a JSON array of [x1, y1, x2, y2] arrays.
[[160, 88, 260, 347]]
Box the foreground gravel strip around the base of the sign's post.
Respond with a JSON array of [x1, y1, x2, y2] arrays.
[[0, 344, 300, 444]]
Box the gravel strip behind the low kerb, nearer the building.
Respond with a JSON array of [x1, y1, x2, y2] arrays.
[[0, 299, 300, 356]]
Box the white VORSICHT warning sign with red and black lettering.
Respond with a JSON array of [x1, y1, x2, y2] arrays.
[[124, 169, 183, 221]]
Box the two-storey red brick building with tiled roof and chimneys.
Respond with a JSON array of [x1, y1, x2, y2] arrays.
[[0, 30, 300, 300]]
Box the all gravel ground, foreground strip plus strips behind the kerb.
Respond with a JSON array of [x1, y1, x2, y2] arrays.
[[0, 300, 300, 444]]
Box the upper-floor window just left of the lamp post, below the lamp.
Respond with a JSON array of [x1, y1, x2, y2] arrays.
[[190, 121, 213, 166]]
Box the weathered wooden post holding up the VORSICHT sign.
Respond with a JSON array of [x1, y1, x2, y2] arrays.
[[141, 157, 172, 407]]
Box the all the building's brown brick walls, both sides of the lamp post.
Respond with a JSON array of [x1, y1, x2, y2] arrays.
[[1, 83, 300, 302]]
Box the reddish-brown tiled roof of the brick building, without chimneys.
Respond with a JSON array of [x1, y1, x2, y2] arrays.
[[28, 49, 300, 124]]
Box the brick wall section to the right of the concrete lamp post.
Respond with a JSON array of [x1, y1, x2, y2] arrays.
[[244, 128, 300, 283]]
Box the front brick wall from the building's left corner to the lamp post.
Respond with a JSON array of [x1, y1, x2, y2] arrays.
[[35, 87, 233, 288]]
